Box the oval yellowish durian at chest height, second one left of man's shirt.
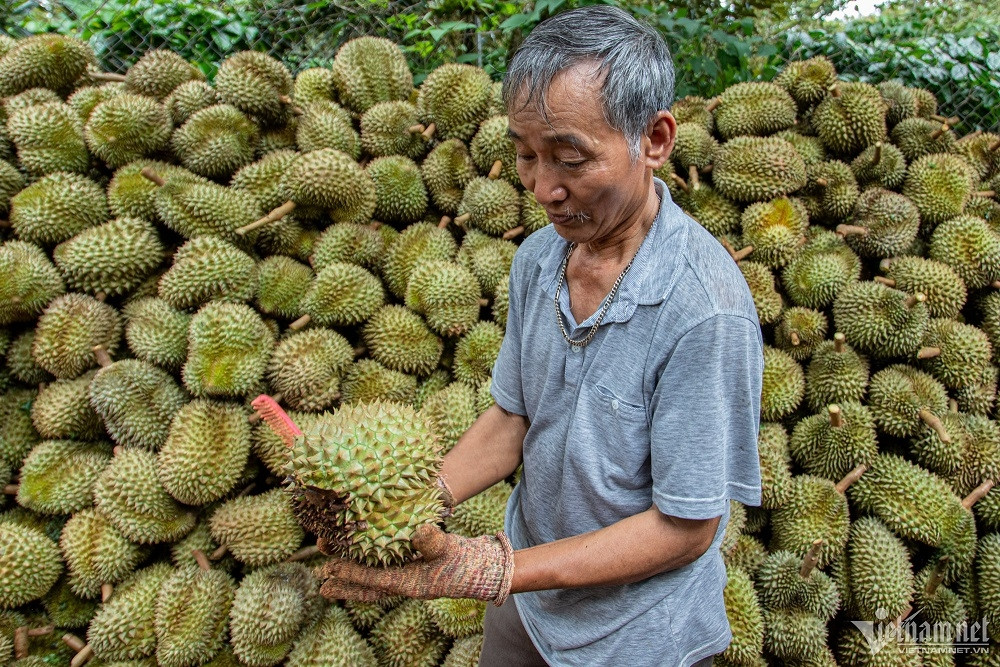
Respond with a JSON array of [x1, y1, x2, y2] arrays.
[[362, 305, 444, 376]]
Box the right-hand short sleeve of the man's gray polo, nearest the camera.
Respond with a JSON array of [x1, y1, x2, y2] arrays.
[[650, 315, 764, 519]]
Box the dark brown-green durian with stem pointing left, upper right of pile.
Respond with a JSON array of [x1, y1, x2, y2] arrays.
[[837, 188, 920, 258]]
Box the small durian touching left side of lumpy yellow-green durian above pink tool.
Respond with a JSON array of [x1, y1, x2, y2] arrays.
[[122, 297, 191, 372]]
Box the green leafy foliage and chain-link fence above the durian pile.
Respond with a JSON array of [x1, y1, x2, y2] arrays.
[[0, 0, 1000, 132]]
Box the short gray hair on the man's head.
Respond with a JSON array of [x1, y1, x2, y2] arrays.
[[503, 5, 674, 164]]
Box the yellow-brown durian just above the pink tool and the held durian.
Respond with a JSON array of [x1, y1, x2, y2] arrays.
[[267, 328, 354, 411]]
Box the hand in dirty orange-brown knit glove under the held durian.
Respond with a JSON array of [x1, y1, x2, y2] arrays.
[[320, 524, 514, 607]]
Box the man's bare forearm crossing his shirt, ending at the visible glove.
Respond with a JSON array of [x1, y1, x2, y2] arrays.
[[511, 505, 721, 593]]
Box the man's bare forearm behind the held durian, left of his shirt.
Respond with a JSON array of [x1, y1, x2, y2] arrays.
[[441, 404, 528, 503]]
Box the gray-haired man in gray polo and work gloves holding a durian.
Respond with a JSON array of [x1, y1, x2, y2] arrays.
[[324, 6, 763, 667]]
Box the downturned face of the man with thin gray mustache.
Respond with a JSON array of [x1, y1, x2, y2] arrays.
[[509, 64, 652, 244]]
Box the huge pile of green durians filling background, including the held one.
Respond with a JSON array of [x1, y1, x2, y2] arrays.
[[0, 27, 1000, 667]]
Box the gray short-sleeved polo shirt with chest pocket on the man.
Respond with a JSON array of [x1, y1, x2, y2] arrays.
[[492, 179, 764, 667]]
